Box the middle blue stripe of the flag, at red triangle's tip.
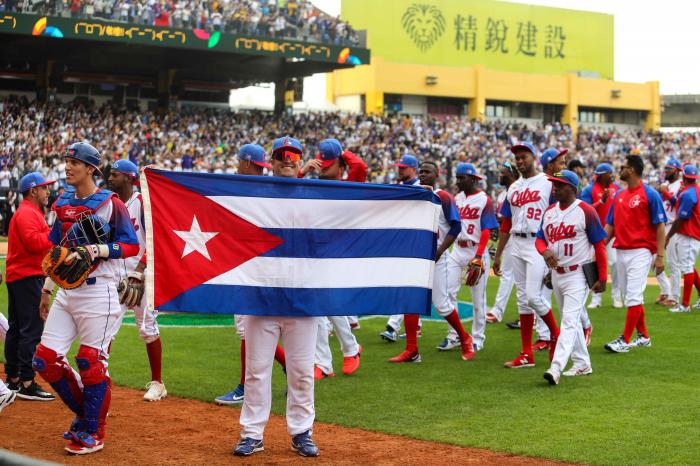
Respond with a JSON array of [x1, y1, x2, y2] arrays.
[[263, 228, 435, 260]]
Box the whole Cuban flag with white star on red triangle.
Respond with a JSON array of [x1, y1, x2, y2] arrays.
[[142, 168, 440, 317]]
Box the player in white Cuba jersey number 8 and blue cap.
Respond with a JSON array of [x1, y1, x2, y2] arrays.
[[442, 163, 498, 351]]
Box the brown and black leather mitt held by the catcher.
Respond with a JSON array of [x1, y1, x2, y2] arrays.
[[41, 246, 93, 290]]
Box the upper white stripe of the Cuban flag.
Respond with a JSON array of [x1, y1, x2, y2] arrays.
[[208, 196, 440, 232]]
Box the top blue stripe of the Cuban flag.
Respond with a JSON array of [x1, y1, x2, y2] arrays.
[[149, 168, 440, 204]]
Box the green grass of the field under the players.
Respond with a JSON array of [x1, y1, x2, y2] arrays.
[[0, 262, 700, 465]]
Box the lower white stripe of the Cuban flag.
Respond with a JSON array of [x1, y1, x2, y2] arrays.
[[206, 256, 435, 288]]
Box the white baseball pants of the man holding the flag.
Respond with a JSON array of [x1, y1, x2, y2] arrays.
[[240, 316, 319, 440]]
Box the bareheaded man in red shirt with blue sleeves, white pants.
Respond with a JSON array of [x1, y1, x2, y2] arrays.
[[605, 155, 666, 353]]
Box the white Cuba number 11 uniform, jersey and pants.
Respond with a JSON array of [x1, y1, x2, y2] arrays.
[[537, 199, 607, 375]]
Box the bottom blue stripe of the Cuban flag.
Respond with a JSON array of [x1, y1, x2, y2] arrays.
[[158, 285, 432, 317]]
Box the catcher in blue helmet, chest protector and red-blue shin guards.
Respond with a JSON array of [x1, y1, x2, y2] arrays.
[[33, 142, 139, 455]]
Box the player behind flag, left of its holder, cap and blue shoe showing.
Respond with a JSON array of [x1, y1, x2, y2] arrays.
[[214, 144, 285, 405]]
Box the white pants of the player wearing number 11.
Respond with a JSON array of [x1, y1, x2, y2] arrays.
[[550, 267, 591, 375]]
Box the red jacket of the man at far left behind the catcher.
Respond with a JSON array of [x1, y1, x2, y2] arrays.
[[5, 199, 53, 282]]
